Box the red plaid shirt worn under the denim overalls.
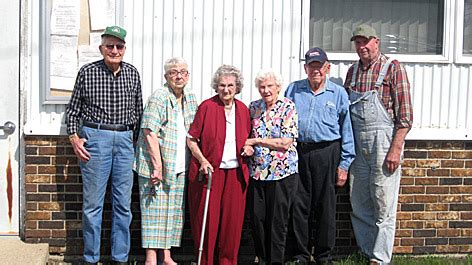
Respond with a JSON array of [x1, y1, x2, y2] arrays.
[[344, 54, 413, 128]]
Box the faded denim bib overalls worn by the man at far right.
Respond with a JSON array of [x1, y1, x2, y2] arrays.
[[349, 59, 401, 264]]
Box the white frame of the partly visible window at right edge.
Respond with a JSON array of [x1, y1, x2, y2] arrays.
[[454, 0, 472, 64]]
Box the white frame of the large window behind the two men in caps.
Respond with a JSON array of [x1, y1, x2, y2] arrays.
[[300, 0, 456, 63]]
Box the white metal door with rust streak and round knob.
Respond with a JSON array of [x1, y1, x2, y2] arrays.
[[0, 0, 20, 235]]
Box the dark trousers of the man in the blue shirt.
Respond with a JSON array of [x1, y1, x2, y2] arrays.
[[293, 141, 341, 261]]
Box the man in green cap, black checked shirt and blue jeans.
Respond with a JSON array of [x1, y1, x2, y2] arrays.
[[66, 26, 143, 264]]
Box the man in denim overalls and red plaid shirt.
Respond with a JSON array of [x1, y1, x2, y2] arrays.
[[344, 25, 413, 264]]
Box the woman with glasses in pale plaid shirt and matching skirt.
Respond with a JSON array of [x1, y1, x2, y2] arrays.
[[134, 58, 197, 264]]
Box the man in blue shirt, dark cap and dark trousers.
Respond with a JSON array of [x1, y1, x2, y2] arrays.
[[285, 47, 355, 264]]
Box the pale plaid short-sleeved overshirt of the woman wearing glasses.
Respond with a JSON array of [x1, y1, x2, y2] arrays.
[[133, 84, 198, 184]]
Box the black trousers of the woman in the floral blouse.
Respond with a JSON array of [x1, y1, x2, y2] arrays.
[[248, 174, 299, 264]]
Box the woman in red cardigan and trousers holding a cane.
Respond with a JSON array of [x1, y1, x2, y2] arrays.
[[187, 65, 253, 264]]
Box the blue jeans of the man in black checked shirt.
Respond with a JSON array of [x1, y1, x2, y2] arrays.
[[80, 127, 134, 263]]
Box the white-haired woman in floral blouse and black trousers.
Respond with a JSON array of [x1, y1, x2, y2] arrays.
[[246, 70, 298, 264]]
